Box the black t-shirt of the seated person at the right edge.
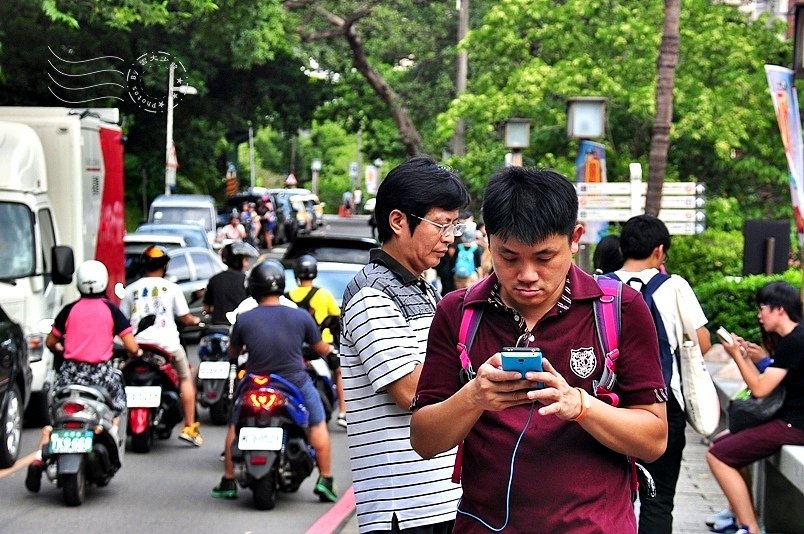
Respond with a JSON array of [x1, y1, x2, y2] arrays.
[[771, 325, 804, 429]]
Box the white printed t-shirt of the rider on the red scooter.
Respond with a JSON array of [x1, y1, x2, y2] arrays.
[[120, 276, 190, 352]]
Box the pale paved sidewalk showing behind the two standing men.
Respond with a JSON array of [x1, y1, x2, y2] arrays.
[[340, 425, 727, 534]]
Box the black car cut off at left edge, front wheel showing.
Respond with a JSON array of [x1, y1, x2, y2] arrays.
[[0, 307, 33, 469]]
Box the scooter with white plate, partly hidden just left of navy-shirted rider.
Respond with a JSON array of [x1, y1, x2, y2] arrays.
[[196, 325, 237, 425]]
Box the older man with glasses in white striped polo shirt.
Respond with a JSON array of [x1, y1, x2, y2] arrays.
[[340, 157, 469, 534]]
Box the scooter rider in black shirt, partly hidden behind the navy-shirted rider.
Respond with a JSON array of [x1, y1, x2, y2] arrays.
[[204, 241, 259, 326]]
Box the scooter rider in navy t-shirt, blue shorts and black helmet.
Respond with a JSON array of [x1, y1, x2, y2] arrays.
[[212, 260, 337, 502]]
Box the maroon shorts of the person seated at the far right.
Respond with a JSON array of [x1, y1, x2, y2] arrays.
[[709, 419, 804, 469]]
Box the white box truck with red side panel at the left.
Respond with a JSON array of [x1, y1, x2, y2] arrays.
[[0, 107, 125, 423]]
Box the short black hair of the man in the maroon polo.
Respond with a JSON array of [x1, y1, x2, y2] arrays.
[[483, 167, 578, 245]]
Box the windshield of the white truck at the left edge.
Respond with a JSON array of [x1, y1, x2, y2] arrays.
[[0, 202, 34, 280]]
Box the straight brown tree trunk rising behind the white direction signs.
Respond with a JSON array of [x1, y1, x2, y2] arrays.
[[645, 0, 681, 216]]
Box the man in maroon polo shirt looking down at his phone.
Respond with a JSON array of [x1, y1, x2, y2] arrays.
[[411, 167, 667, 533]]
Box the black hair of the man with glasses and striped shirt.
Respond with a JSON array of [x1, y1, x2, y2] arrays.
[[374, 156, 470, 243]]
